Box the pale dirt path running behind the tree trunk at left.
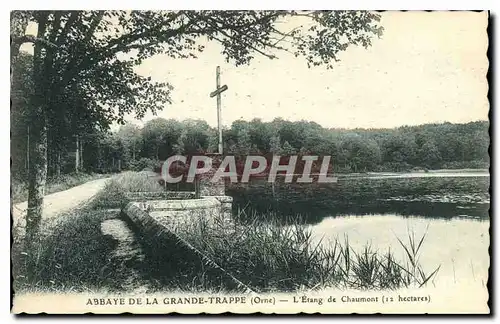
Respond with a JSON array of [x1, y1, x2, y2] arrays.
[[12, 178, 110, 227]]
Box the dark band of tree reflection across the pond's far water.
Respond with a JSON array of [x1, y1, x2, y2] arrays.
[[228, 175, 489, 224]]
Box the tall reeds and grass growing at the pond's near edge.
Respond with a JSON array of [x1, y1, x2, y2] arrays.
[[178, 211, 439, 292]]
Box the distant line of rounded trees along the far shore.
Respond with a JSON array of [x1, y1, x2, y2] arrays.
[[11, 114, 489, 179]]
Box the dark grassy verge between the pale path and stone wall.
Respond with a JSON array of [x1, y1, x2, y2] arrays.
[[12, 172, 162, 292]]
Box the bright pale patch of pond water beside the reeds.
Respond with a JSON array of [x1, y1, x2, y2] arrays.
[[311, 214, 490, 287]]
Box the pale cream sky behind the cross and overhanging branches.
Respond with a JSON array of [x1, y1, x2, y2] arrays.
[[22, 12, 489, 128]]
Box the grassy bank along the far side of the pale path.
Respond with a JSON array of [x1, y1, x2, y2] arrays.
[[11, 173, 110, 203]]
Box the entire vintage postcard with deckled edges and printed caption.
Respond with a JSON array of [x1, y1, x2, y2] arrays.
[[10, 11, 490, 314]]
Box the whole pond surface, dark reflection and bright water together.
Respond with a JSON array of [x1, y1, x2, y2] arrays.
[[228, 172, 490, 289]]
